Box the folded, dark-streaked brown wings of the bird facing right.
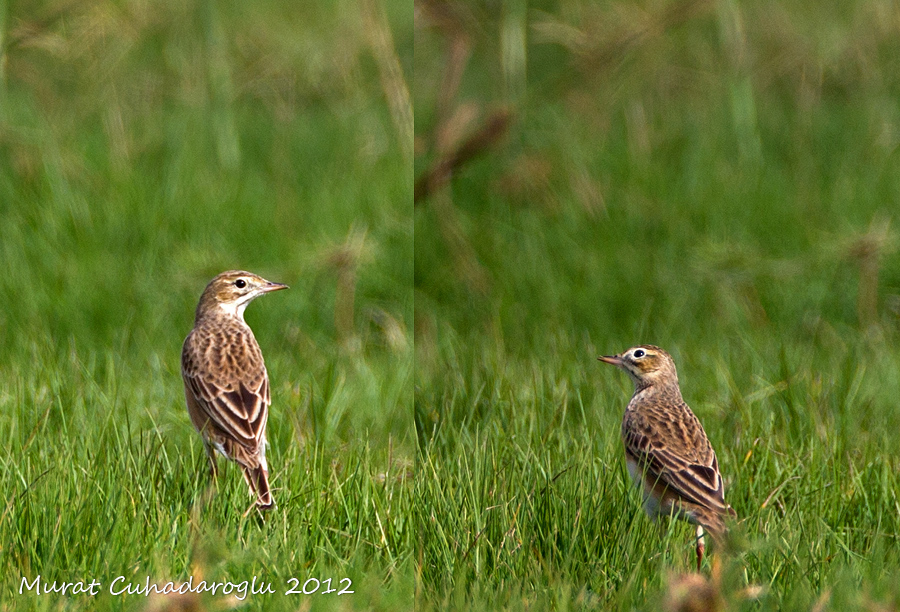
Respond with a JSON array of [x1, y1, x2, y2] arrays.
[[181, 332, 270, 449]]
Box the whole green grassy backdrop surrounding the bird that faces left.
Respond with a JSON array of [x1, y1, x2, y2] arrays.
[[413, 0, 900, 610]]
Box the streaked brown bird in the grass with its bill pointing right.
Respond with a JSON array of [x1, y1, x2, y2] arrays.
[[181, 270, 288, 510]]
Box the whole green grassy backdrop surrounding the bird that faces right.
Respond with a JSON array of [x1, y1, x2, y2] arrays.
[[0, 0, 415, 610]]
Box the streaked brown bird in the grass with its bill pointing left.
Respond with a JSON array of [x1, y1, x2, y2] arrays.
[[599, 344, 737, 571]]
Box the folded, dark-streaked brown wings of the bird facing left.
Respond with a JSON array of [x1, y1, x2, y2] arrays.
[[623, 412, 733, 513]]
